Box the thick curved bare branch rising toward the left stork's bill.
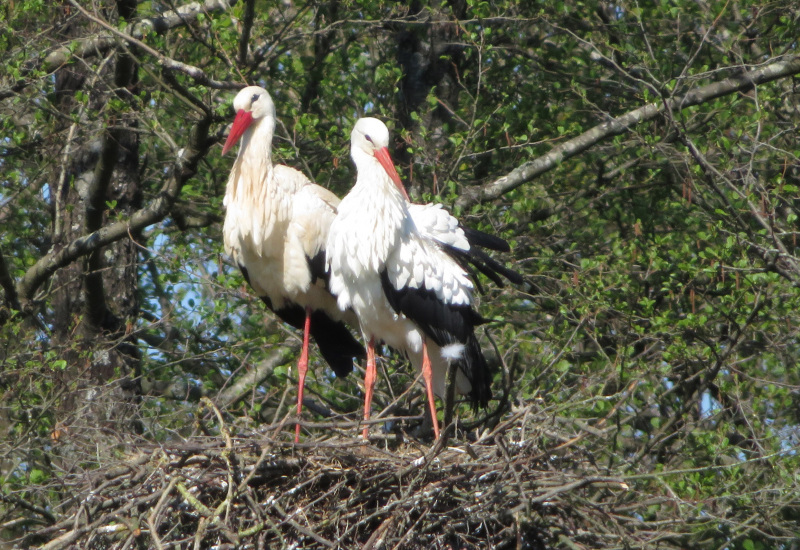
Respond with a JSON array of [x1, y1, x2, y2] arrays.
[[17, 117, 211, 307]]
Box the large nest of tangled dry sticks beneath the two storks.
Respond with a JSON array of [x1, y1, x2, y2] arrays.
[[10, 407, 631, 549]]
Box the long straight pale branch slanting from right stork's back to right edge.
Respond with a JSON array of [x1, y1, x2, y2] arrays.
[[456, 56, 800, 209]]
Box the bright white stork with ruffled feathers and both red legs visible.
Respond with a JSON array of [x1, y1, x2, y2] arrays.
[[326, 118, 520, 438]]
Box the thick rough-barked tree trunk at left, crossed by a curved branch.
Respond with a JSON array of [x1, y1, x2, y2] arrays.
[[49, 0, 142, 440]]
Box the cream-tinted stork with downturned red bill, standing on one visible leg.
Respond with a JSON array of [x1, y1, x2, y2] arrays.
[[222, 86, 364, 442]]
